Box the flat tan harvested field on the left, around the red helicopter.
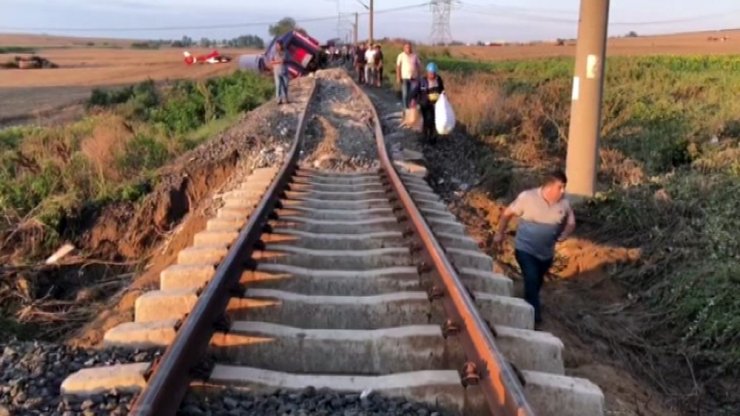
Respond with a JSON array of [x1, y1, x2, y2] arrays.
[[0, 35, 255, 125]]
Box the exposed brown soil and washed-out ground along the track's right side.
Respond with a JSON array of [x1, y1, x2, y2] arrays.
[[369, 83, 678, 416]]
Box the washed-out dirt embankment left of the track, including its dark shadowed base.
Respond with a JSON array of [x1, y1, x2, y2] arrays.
[[0, 79, 313, 346]]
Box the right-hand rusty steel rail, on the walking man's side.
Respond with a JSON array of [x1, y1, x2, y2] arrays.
[[352, 83, 535, 416]]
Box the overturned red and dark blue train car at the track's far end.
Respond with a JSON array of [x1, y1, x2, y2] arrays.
[[239, 30, 326, 78]]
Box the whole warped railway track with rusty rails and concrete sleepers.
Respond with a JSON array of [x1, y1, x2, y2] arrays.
[[57, 70, 604, 415]]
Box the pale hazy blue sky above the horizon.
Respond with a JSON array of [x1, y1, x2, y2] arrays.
[[0, 0, 740, 42]]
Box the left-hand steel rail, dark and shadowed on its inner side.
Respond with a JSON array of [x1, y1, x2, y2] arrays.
[[129, 82, 316, 416]]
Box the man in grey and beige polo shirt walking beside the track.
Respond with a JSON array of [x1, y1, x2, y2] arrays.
[[493, 170, 576, 324]]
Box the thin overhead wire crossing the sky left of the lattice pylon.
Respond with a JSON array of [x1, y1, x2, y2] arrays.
[[0, 1, 430, 32]]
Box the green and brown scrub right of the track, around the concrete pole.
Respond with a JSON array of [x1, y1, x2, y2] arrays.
[[433, 54, 740, 406]]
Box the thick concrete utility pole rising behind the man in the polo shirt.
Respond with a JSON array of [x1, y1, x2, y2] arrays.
[[566, 0, 609, 197]]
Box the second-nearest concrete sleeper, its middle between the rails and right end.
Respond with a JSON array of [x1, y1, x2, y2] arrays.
[[211, 321, 564, 375]]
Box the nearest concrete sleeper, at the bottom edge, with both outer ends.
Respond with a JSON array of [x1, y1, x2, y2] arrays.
[[61, 363, 604, 416]]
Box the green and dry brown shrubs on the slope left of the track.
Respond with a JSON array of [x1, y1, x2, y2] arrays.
[[0, 72, 272, 257]]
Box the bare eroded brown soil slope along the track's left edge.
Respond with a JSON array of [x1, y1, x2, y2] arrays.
[[69, 78, 313, 347]]
